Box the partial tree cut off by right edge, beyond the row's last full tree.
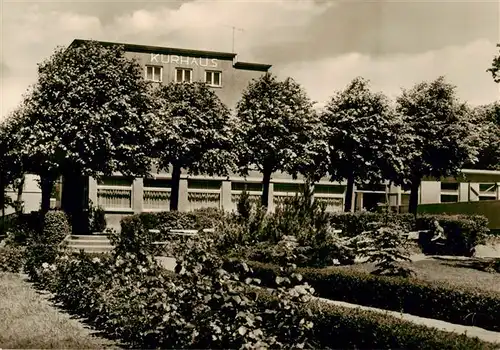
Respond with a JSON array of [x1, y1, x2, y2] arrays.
[[465, 102, 500, 170]]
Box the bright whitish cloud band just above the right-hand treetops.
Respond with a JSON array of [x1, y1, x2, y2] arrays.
[[275, 40, 500, 105]]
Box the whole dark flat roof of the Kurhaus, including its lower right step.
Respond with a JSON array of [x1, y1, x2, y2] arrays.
[[69, 39, 272, 71]]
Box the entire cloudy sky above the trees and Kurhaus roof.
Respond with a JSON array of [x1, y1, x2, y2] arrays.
[[0, 0, 500, 119]]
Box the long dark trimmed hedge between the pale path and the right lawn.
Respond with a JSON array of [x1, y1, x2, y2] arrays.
[[232, 261, 500, 331]]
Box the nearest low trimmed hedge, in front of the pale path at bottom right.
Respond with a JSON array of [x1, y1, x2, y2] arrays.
[[257, 290, 500, 350]]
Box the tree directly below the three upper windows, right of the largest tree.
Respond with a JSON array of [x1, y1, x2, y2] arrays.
[[154, 82, 235, 210]]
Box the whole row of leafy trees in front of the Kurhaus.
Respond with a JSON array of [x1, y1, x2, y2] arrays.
[[0, 42, 500, 232]]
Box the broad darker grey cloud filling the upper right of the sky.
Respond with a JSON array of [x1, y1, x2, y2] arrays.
[[255, 0, 500, 63]]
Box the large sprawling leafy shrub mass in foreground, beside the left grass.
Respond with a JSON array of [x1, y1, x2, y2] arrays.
[[36, 231, 312, 348]]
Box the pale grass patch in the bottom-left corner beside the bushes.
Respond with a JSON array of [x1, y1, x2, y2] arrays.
[[0, 273, 119, 349]]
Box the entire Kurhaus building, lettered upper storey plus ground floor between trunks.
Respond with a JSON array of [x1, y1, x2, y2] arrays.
[[20, 40, 500, 229]]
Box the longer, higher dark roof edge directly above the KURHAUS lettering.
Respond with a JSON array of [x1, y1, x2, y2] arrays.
[[69, 39, 236, 60]]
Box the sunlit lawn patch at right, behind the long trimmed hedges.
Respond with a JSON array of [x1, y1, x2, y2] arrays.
[[333, 257, 500, 292]]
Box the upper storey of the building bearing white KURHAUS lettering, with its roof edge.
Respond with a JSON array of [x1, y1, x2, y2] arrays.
[[71, 39, 271, 109]]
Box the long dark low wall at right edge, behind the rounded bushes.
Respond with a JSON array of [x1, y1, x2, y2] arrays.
[[418, 200, 500, 231]]
